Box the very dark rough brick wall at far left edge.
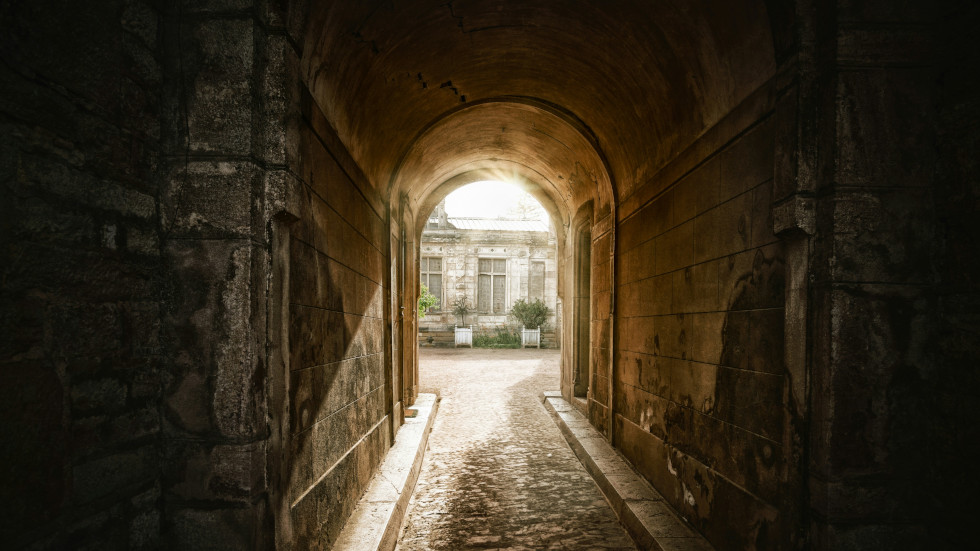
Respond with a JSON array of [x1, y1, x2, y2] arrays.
[[0, 0, 162, 549]]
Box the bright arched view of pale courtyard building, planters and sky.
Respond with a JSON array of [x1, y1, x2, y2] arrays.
[[418, 180, 560, 348]]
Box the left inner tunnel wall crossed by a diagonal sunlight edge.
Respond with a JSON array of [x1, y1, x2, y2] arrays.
[[289, 94, 391, 549]]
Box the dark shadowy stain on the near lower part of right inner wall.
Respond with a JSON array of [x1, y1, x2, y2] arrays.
[[664, 249, 787, 549]]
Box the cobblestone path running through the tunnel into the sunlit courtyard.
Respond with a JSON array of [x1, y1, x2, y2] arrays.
[[398, 349, 635, 551]]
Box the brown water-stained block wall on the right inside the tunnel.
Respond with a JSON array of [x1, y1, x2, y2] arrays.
[[612, 114, 785, 549]]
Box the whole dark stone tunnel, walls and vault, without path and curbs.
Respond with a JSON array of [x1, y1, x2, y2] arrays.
[[0, 0, 980, 551]]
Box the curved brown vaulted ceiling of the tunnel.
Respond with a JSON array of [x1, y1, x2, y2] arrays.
[[303, 0, 775, 222]]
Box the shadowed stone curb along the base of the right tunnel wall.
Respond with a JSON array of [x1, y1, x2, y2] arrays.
[[541, 391, 714, 551]]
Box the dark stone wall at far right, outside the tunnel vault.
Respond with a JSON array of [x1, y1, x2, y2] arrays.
[[796, 2, 978, 549]]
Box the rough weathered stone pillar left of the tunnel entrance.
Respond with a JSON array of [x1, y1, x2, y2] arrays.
[[153, 0, 303, 549]]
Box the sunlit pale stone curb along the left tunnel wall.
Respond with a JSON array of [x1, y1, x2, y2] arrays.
[[333, 394, 439, 551]]
